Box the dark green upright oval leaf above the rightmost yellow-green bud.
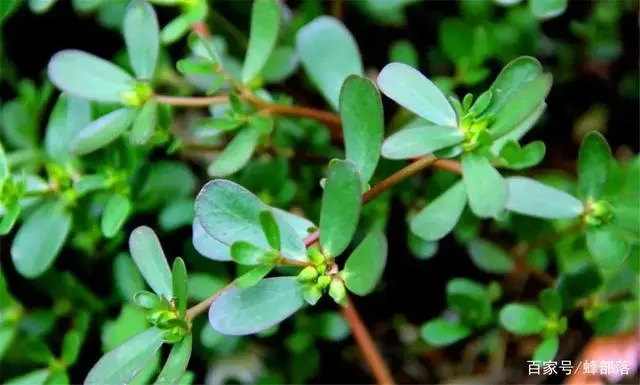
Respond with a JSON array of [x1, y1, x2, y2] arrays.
[[578, 131, 613, 200]]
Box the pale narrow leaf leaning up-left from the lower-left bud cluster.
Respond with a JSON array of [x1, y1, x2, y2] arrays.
[[129, 226, 173, 299]]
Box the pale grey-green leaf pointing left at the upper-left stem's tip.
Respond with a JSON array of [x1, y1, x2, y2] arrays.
[[47, 50, 135, 103]]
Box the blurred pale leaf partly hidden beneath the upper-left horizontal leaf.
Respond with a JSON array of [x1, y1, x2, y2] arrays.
[[44, 94, 91, 162]]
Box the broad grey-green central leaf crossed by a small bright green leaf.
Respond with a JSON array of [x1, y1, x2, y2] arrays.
[[196, 179, 307, 261]]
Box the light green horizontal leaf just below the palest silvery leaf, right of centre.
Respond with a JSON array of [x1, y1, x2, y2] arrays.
[[382, 126, 464, 159]]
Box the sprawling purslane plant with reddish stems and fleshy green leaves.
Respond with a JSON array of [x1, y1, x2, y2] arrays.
[[0, 0, 640, 384]]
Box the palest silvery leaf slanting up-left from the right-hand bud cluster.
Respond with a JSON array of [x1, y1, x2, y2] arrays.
[[377, 63, 458, 127]]
